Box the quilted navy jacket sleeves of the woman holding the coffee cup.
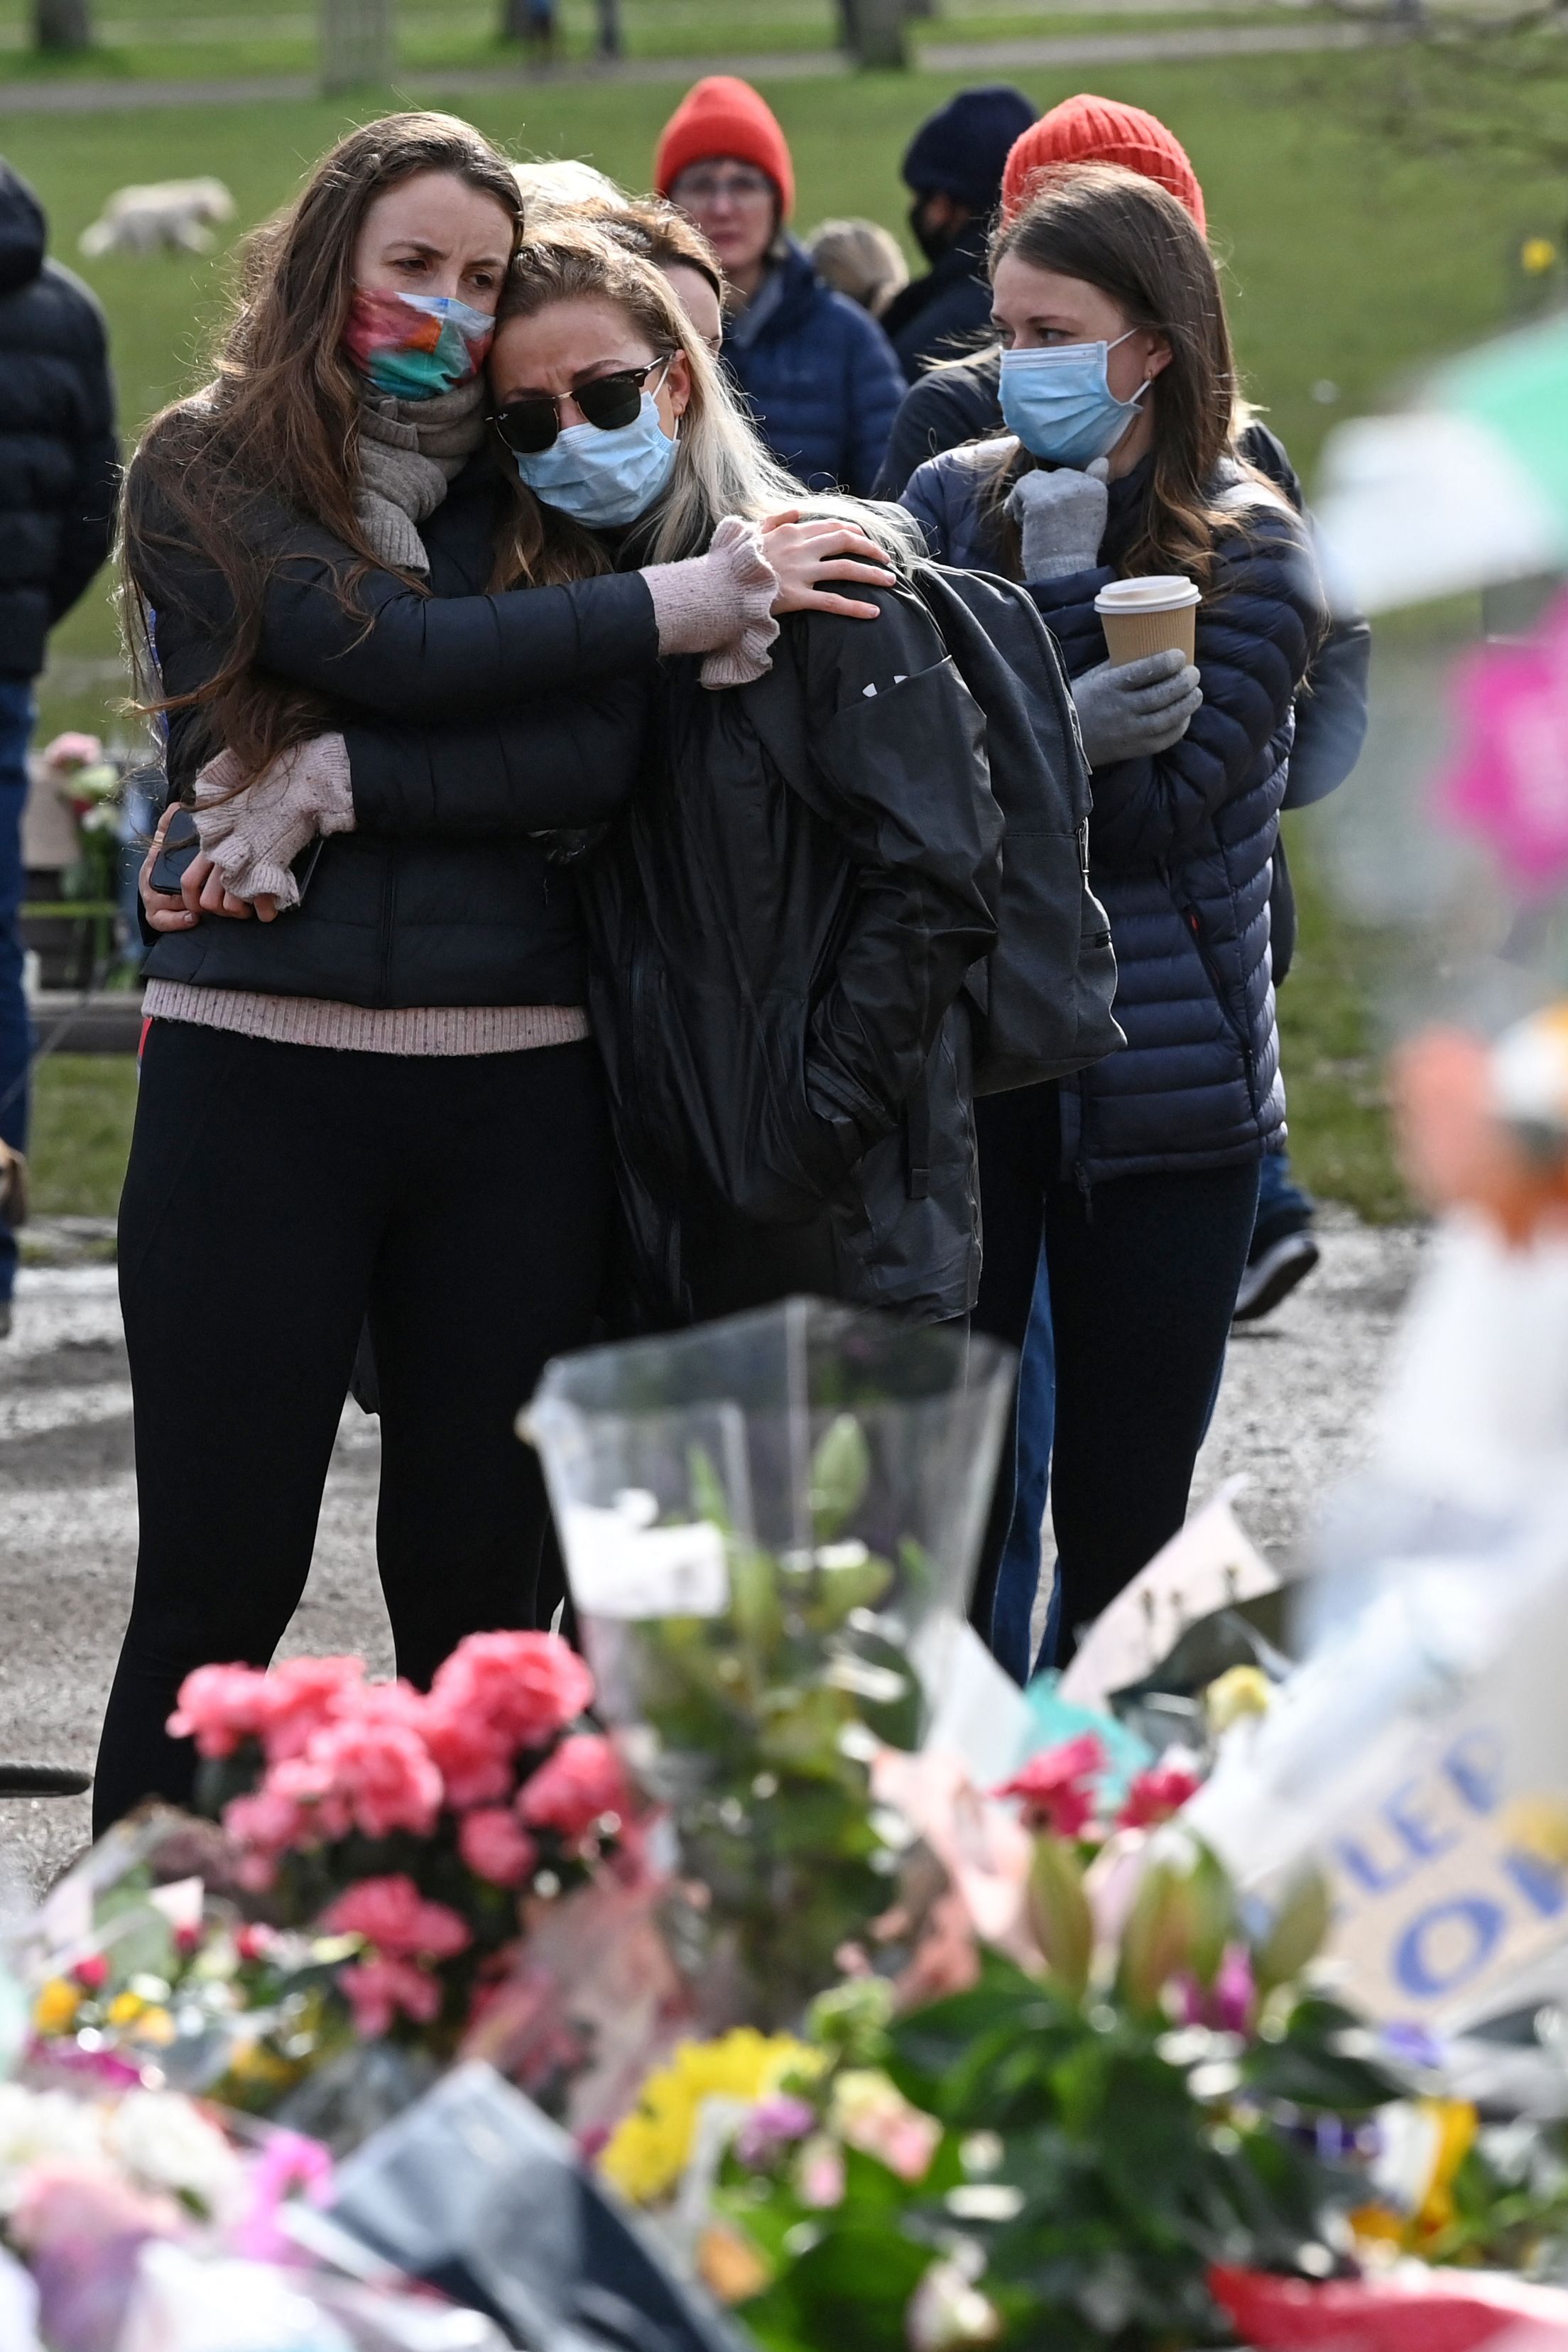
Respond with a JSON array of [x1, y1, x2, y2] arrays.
[[1032, 503, 1326, 866]]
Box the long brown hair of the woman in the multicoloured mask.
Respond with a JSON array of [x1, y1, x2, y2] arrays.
[[122, 113, 522, 771]]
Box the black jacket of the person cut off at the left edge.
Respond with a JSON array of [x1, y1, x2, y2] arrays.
[[0, 163, 120, 677]]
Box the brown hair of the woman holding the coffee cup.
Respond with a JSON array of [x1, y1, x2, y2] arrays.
[[990, 163, 1267, 588]]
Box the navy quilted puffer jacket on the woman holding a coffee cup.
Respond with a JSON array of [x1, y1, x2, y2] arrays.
[[903, 447, 1324, 1183]]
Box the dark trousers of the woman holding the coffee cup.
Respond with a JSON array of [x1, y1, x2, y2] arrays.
[[971, 1087, 1258, 1663]]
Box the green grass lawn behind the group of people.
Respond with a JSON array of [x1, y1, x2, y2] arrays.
[[15, 41, 1542, 1214]]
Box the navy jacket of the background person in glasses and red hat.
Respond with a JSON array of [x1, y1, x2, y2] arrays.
[[724, 242, 905, 499]]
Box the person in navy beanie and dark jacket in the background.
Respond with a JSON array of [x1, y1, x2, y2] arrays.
[[881, 82, 1035, 383]]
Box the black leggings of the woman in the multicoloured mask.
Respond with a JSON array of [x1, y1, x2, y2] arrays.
[[94, 1020, 611, 1830]]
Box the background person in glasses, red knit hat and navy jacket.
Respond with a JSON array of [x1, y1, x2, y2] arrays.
[[653, 73, 905, 496]]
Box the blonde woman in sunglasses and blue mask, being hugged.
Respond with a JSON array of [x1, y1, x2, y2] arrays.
[[489, 224, 1001, 1322]]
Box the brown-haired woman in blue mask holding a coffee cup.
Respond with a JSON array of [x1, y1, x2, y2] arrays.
[[903, 165, 1324, 1656]]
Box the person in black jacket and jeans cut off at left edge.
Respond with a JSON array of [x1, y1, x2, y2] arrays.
[[0, 163, 120, 1339]]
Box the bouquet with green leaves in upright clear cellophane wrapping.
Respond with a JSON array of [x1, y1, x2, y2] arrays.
[[527, 1298, 1011, 2025]]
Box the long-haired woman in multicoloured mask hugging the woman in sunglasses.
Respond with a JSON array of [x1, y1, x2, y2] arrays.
[[107, 115, 884, 1825]]
